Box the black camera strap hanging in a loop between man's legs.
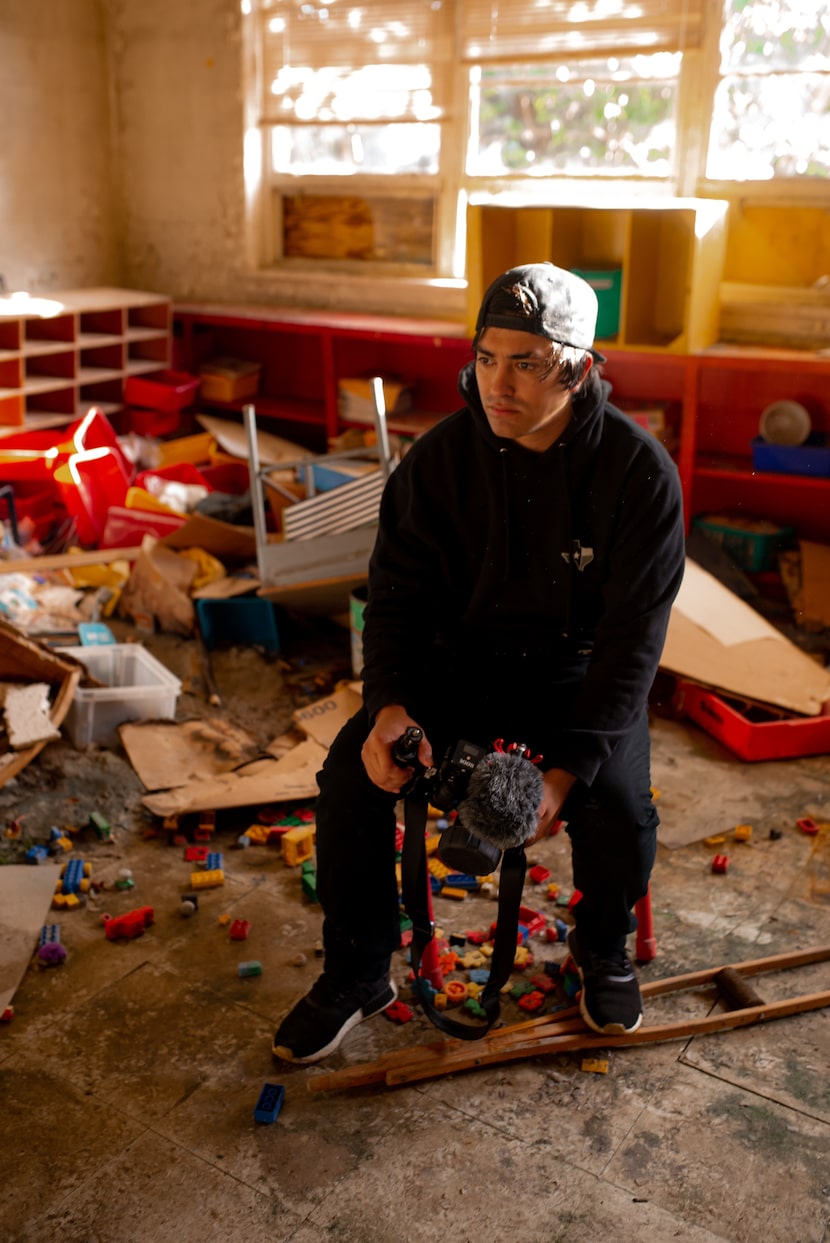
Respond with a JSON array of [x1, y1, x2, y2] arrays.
[[401, 778, 527, 1040]]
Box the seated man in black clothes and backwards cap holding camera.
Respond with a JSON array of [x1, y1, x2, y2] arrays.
[[273, 264, 685, 1063]]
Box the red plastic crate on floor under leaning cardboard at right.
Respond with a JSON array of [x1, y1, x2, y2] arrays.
[[675, 681, 830, 761]]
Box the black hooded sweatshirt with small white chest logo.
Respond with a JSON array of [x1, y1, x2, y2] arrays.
[[363, 363, 685, 784]]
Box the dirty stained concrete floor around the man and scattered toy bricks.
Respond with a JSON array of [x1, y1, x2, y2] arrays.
[[0, 631, 830, 1243]]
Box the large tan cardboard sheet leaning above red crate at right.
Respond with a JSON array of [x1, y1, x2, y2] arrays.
[[660, 561, 830, 716]]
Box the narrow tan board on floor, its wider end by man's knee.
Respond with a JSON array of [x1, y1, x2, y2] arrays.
[[142, 738, 326, 817]]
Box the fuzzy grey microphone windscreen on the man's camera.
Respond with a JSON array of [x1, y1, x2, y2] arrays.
[[458, 751, 544, 850]]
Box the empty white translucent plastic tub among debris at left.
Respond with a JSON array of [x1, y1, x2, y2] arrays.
[[57, 643, 181, 747]]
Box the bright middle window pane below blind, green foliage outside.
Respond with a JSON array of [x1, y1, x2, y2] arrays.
[[467, 53, 680, 177]]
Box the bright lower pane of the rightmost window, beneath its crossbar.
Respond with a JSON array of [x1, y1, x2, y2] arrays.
[[706, 73, 830, 181]]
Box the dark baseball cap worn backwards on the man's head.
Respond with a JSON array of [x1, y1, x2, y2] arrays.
[[476, 262, 605, 363]]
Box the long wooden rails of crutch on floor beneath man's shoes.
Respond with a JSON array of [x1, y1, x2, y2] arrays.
[[308, 946, 830, 1093]]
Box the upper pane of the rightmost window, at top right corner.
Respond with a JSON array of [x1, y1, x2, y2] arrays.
[[721, 0, 830, 73]]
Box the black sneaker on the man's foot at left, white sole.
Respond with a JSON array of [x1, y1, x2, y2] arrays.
[[272, 972, 398, 1062]]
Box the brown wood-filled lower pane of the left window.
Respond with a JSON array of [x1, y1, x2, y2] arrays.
[[282, 194, 434, 265]]
